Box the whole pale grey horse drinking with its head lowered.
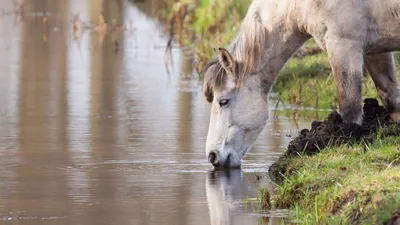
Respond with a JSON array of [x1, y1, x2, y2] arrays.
[[204, 0, 400, 167]]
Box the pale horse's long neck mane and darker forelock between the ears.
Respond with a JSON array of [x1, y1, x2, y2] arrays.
[[202, 4, 267, 101]]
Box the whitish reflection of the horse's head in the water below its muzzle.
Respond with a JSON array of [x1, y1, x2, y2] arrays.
[[206, 169, 281, 225]]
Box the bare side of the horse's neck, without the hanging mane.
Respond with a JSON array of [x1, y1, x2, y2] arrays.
[[249, 0, 310, 76]]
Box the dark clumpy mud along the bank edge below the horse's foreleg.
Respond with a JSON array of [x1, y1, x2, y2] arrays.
[[269, 98, 400, 183]]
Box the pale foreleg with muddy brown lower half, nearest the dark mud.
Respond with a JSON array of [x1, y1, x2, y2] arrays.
[[326, 40, 363, 124]]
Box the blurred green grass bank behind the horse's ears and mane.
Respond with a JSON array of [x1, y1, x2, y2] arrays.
[[162, 0, 251, 70]]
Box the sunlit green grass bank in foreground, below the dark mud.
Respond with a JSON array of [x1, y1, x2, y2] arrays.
[[273, 137, 400, 224]]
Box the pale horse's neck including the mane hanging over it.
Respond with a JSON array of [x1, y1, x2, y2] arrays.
[[229, 0, 310, 86]]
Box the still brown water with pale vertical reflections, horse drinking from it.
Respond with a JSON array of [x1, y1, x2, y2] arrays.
[[0, 0, 316, 225]]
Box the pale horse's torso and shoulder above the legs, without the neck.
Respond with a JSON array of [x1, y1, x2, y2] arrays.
[[294, 0, 400, 54]]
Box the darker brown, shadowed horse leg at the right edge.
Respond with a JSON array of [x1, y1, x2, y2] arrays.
[[364, 53, 400, 122]]
